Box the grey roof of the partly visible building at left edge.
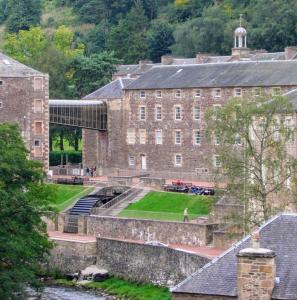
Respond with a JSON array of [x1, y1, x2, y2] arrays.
[[0, 52, 44, 77]]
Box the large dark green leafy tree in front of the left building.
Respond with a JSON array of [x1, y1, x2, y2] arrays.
[[0, 124, 52, 299]]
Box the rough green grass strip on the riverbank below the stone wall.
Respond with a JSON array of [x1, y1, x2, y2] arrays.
[[84, 278, 171, 300]]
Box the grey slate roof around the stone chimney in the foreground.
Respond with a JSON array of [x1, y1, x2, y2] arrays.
[[173, 214, 297, 300]]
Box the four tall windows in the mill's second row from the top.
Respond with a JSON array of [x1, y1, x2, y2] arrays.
[[139, 104, 201, 121]]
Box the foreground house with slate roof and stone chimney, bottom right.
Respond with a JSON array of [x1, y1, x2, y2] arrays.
[[172, 214, 297, 300]]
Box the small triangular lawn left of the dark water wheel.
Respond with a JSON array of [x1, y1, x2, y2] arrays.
[[47, 184, 93, 211]]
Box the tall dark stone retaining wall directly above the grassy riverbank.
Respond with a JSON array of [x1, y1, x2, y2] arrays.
[[97, 238, 209, 286]]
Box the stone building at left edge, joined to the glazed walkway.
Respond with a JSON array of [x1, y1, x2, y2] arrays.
[[0, 53, 49, 170]]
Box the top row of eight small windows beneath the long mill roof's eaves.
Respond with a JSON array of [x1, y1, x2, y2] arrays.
[[139, 87, 281, 99]]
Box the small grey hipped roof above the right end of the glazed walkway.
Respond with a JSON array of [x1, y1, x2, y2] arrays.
[[83, 78, 135, 100]]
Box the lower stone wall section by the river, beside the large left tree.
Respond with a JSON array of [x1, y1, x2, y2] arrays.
[[48, 239, 97, 274]]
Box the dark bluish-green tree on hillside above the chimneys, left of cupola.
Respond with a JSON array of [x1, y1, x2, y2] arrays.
[[148, 20, 174, 62]]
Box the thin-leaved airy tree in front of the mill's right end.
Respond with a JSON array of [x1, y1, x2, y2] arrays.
[[207, 95, 297, 227]]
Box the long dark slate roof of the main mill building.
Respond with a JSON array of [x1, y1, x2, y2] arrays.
[[126, 60, 297, 90]]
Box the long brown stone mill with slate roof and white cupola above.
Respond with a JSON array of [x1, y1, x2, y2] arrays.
[[84, 27, 297, 180]]
